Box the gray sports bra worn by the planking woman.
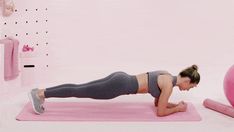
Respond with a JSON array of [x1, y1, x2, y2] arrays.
[[147, 71, 177, 98]]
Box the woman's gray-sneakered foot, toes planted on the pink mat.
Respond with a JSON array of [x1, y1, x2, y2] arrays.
[[29, 88, 45, 114]]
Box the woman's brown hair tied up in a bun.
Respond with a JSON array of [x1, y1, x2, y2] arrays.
[[179, 65, 200, 84]]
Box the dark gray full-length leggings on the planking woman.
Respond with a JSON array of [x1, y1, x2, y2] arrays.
[[45, 72, 138, 99]]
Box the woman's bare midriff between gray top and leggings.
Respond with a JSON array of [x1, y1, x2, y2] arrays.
[[136, 73, 148, 93]]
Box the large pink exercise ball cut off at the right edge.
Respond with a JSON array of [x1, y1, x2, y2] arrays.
[[223, 65, 234, 107]]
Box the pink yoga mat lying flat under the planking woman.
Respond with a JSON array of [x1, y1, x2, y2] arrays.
[[16, 102, 201, 122]]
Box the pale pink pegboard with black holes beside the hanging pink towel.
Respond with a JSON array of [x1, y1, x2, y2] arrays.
[[0, 0, 50, 85]]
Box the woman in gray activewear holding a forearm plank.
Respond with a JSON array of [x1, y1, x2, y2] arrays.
[[29, 65, 200, 116]]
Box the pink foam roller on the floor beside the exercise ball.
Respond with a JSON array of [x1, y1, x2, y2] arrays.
[[203, 99, 234, 117]]
